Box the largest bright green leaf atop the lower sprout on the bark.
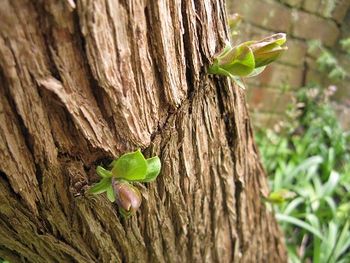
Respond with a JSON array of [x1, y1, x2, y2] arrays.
[[112, 150, 147, 181]]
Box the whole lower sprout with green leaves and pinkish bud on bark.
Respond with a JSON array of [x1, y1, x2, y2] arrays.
[[89, 150, 161, 216]]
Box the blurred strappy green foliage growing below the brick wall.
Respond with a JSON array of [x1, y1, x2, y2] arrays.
[[257, 87, 350, 263]]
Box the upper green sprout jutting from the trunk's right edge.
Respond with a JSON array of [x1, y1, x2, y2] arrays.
[[208, 33, 287, 89]]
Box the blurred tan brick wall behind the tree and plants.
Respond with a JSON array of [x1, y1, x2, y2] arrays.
[[227, 0, 350, 130]]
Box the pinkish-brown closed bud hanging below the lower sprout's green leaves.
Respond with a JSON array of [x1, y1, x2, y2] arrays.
[[112, 178, 142, 215]]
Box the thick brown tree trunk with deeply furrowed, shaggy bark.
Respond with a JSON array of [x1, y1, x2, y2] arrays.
[[0, 0, 286, 263]]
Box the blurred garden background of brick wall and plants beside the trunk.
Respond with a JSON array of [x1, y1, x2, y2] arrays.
[[227, 0, 350, 262]]
